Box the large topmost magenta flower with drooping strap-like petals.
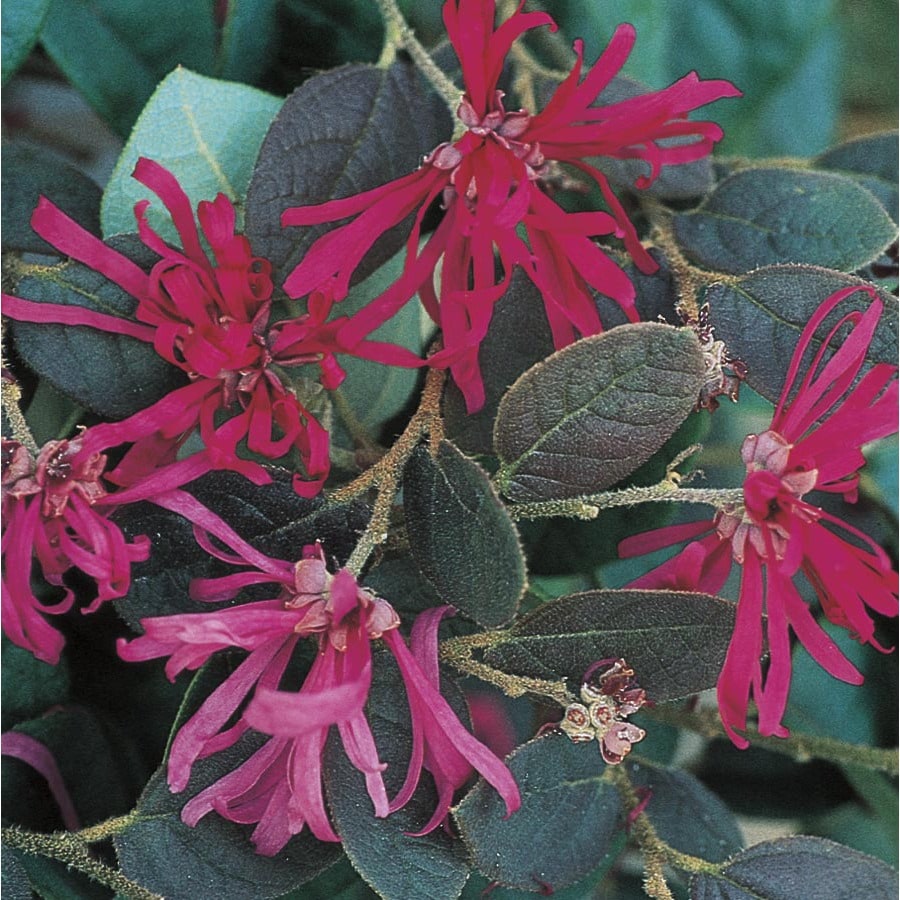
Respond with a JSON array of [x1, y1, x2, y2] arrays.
[[282, 0, 740, 411]]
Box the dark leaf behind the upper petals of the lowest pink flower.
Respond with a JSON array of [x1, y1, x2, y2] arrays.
[[116, 469, 369, 628]]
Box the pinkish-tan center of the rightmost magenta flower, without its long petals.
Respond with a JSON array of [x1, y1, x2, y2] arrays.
[[716, 431, 818, 563]]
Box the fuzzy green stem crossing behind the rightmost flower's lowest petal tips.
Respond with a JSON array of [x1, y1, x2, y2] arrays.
[[646, 706, 898, 775]]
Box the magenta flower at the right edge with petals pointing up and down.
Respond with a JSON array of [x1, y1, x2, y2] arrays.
[[619, 287, 898, 748]]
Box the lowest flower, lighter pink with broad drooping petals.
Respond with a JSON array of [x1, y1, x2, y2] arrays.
[[119, 540, 519, 855]]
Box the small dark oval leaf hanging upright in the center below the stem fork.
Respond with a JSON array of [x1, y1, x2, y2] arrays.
[[403, 441, 525, 626]]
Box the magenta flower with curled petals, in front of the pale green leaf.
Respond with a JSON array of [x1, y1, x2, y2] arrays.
[[4, 158, 352, 496]]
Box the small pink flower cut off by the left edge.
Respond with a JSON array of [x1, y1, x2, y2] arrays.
[[2, 432, 150, 665]]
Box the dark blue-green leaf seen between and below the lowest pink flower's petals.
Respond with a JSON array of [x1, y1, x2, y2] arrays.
[[325, 654, 468, 900]]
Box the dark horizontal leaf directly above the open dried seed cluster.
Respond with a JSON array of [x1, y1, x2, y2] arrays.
[[485, 590, 735, 702]]
